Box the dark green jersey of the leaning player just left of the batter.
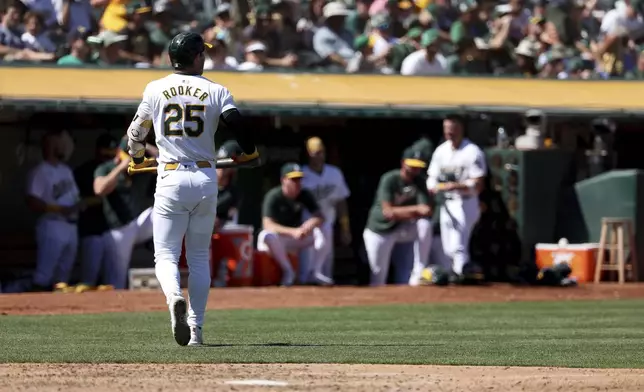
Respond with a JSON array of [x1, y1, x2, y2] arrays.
[[94, 161, 149, 229]]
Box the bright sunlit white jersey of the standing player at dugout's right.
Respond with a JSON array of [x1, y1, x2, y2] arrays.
[[427, 139, 487, 198]]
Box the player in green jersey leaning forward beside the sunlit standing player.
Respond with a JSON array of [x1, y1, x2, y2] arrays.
[[363, 149, 433, 286]]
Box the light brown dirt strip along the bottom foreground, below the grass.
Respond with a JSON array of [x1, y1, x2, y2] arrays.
[[0, 364, 644, 392]]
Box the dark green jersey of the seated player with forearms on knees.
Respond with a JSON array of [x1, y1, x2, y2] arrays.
[[262, 185, 320, 227]]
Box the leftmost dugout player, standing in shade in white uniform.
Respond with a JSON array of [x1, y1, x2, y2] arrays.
[[27, 132, 84, 291]]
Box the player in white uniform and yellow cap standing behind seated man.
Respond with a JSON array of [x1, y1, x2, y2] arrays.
[[299, 137, 351, 284]]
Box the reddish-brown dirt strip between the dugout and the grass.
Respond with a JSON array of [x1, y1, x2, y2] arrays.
[[0, 284, 644, 315]]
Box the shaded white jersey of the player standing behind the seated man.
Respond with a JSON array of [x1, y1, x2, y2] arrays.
[[302, 164, 351, 225]]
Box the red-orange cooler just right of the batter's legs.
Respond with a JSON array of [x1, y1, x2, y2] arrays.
[[179, 225, 254, 287]]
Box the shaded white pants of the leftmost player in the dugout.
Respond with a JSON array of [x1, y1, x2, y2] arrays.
[[33, 219, 78, 287]]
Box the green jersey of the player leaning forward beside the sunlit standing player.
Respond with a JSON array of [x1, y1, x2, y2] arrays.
[[367, 169, 431, 233]]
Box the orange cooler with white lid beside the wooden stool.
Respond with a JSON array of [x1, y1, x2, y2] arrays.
[[536, 243, 599, 283]]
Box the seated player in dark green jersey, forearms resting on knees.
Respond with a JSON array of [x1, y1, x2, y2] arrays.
[[257, 163, 325, 286]]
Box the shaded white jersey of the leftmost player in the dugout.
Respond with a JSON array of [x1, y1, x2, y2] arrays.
[[27, 161, 80, 219]]
